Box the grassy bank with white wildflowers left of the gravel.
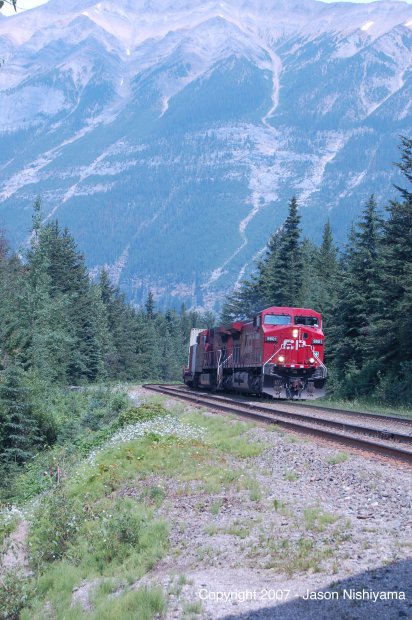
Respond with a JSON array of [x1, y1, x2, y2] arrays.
[[0, 399, 264, 620]]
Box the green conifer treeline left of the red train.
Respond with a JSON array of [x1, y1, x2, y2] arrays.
[[0, 201, 213, 480]]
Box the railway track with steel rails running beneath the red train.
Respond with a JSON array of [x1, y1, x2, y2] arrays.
[[143, 384, 412, 464]]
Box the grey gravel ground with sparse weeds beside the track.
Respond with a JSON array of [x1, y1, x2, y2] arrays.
[[132, 390, 412, 620]]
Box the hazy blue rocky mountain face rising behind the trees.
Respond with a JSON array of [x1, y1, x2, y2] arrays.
[[0, 0, 412, 308]]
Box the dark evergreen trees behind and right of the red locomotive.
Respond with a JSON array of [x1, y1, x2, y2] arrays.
[[222, 138, 412, 406]]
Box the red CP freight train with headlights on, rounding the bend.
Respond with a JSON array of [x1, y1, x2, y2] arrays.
[[183, 306, 327, 398]]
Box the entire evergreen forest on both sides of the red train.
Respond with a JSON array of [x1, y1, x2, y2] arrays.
[[0, 137, 412, 499]]
